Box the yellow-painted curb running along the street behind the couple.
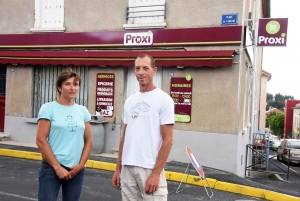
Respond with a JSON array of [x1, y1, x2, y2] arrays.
[[0, 148, 300, 201]]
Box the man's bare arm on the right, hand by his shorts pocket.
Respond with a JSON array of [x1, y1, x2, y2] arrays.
[[145, 124, 173, 193]]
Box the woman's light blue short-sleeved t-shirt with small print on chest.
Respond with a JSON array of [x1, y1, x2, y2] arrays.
[[38, 101, 91, 167]]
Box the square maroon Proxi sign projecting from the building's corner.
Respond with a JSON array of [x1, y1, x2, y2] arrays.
[[257, 18, 288, 46]]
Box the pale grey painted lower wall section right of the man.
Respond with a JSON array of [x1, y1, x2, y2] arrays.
[[169, 130, 238, 176]]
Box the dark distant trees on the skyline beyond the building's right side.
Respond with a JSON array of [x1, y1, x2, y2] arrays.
[[266, 93, 294, 111]]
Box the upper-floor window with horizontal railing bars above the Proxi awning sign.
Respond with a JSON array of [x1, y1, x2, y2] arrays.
[[123, 0, 167, 29]]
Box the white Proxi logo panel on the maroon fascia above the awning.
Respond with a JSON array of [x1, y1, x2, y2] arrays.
[[124, 31, 153, 46]]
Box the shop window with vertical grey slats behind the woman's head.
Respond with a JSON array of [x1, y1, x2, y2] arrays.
[[32, 65, 89, 118]]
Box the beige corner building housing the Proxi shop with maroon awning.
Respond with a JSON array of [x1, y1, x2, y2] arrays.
[[0, 0, 270, 176]]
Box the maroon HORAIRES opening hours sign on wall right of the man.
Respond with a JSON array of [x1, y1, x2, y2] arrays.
[[170, 75, 193, 123]]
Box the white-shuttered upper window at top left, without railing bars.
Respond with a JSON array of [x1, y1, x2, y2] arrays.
[[30, 0, 65, 32]]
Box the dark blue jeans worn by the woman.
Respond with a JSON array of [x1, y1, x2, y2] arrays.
[[38, 160, 85, 201]]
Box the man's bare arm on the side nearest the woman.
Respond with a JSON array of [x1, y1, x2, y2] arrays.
[[112, 124, 127, 189]]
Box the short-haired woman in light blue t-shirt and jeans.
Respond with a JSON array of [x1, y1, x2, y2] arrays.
[[36, 68, 92, 201]]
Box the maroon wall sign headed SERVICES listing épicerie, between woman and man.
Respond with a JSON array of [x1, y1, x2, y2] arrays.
[[96, 73, 115, 117]]
